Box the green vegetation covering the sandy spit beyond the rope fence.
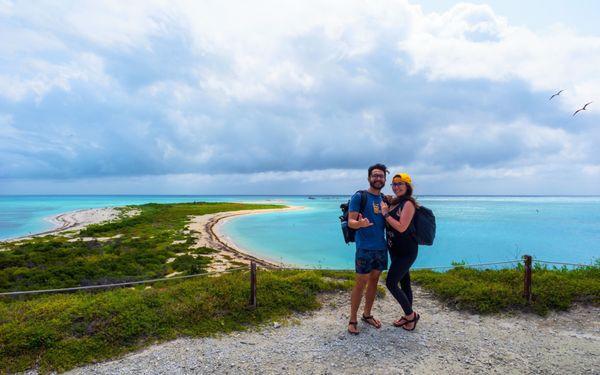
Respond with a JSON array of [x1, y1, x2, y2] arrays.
[[0, 203, 282, 292]]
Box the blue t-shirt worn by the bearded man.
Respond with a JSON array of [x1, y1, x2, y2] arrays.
[[348, 191, 387, 250]]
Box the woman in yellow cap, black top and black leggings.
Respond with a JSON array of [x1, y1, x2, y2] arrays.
[[382, 173, 420, 331]]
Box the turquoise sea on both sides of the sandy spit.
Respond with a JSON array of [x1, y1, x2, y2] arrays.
[[0, 196, 600, 268]]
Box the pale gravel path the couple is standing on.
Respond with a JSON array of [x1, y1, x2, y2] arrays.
[[70, 288, 600, 374]]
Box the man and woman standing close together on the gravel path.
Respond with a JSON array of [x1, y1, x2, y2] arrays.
[[348, 164, 420, 334]]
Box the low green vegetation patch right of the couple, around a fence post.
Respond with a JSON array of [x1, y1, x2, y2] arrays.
[[410, 261, 600, 315]]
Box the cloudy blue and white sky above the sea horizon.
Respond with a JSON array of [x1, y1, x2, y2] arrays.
[[0, 0, 600, 195]]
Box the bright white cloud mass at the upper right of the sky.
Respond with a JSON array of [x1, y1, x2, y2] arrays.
[[399, 4, 600, 111]]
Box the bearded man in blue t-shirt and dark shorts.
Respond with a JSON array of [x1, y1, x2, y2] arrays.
[[348, 164, 389, 335]]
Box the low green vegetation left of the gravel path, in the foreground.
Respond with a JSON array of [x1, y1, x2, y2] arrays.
[[0, 270, 351, 373]]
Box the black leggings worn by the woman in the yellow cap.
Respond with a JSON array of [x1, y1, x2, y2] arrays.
[[385, 248, 418, 315]]
